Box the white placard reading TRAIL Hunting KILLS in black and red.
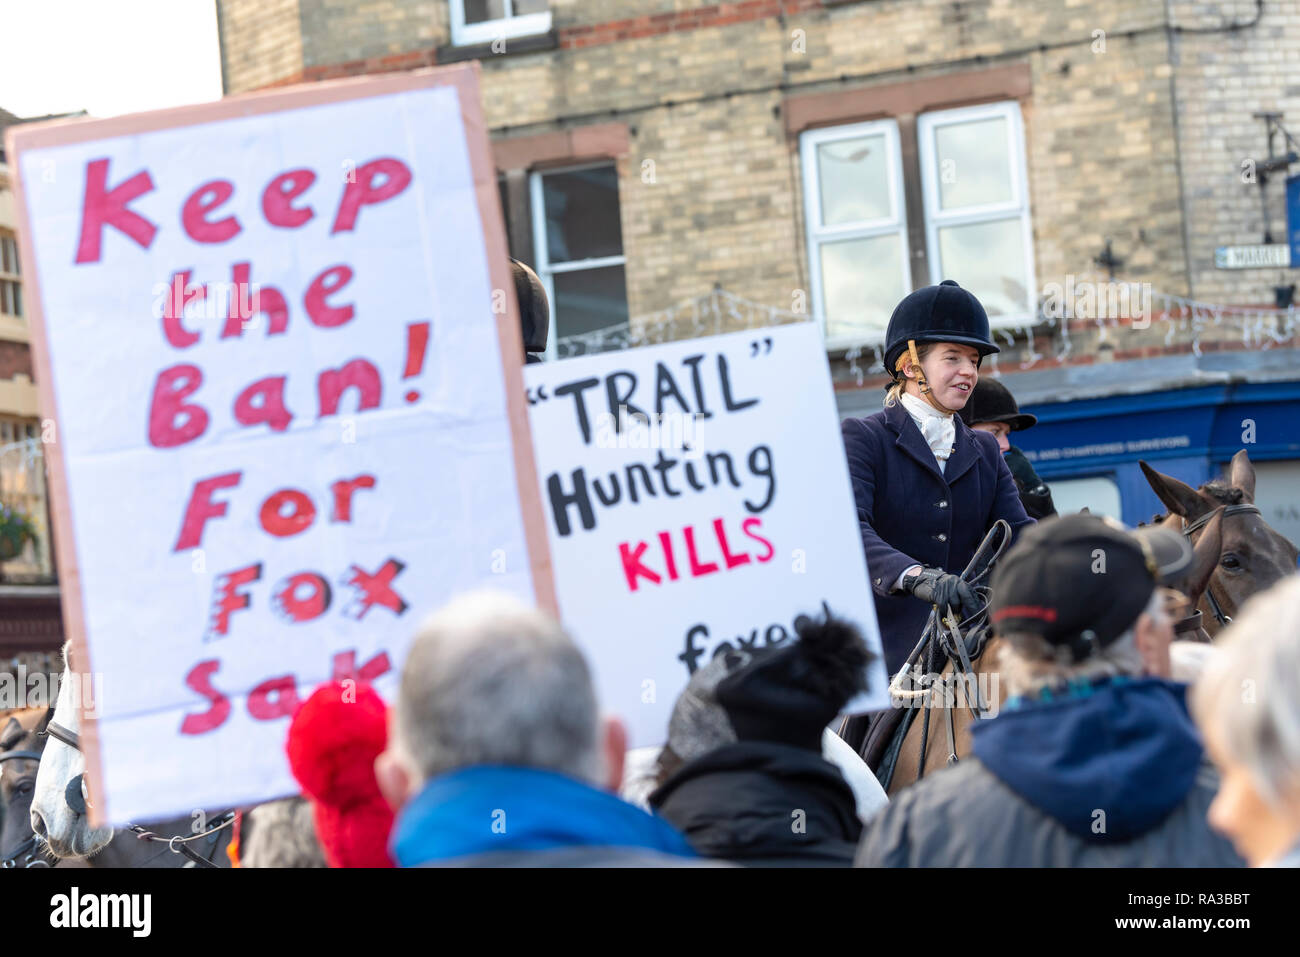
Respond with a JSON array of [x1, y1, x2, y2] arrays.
[[524, 322, 889, 746]]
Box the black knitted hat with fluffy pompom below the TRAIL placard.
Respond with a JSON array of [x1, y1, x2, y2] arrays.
[[715, 610, 872, 752]]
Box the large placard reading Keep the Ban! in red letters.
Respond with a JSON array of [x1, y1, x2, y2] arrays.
[[1, 66, 554, 823]]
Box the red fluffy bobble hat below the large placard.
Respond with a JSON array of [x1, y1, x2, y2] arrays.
[[285, 681, 393, 867]]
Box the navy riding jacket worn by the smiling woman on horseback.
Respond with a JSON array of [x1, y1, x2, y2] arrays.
[[840, 403, 1032, 675]]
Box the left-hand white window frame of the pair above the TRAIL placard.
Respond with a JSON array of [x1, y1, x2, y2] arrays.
[[800, 120, 911, 350]]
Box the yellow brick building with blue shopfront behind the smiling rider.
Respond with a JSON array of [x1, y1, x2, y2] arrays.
[[217, 0, 1300, 538]]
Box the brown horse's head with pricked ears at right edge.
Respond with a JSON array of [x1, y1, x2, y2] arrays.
[[1139, 449, 1297, 635]]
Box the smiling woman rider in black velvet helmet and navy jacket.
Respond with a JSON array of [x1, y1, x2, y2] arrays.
[[841, 280, 1032, 675]]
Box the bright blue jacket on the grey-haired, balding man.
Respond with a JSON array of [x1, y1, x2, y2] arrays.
[[391, 765, 696, 867]]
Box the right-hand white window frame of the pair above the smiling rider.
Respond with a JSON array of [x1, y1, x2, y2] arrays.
[[917, 100, 1039, 329]]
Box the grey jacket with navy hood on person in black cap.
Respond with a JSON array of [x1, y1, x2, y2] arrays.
[[857, 679, 1243, 867]]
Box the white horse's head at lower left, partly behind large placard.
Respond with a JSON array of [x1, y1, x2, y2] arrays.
[[31, 648, 113, 858]]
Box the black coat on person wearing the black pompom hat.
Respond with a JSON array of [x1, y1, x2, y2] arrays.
[[650, 741, 862, 867]]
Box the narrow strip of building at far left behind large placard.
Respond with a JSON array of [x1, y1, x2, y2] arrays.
[[0, 109, 62, 668]]
